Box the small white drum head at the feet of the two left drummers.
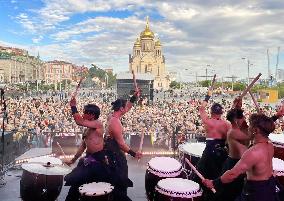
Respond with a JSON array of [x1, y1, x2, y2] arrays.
[[79, 182, 114, 197]]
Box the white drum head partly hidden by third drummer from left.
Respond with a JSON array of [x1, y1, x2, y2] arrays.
[[179, 143, 206, 158]]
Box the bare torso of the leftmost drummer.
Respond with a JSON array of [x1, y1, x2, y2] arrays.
[[83, 128, 104, 153]]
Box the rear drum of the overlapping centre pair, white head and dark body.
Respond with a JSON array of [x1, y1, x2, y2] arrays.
[[145, 157, 182, 201]]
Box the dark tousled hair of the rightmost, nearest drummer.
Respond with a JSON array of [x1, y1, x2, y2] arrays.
[[249, 114, 275, 137]]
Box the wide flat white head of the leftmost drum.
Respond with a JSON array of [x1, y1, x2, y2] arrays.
[[22, 163, 71, 175]]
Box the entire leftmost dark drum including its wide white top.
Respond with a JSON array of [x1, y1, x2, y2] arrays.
[[20, 157, 71, 201]]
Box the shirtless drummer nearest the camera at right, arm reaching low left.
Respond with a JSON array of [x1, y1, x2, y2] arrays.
[[203, 114, 279, 201]]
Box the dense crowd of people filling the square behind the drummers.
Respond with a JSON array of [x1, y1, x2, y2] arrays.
[[0, 88, 283, 155]]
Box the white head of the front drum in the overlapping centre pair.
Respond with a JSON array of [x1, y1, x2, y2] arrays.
[[155, 178, 202, 198]]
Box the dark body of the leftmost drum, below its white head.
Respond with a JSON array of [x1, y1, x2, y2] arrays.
[[20, 170, 63, 201]]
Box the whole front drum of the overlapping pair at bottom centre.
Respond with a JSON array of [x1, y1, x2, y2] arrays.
[[154, 178, 202, 201]]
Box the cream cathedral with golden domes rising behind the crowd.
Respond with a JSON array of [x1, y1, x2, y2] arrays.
[[129, 17, 170, 90]]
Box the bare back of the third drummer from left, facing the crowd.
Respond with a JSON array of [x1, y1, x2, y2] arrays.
[[205, 119, 229, 139]]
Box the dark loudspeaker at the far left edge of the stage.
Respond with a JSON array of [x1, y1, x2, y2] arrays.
[[0, 131, 15, 165]]
